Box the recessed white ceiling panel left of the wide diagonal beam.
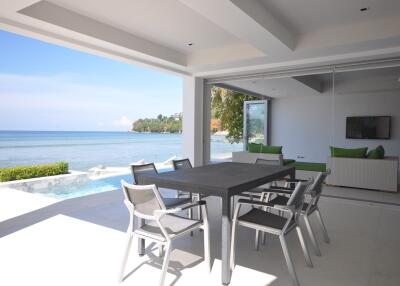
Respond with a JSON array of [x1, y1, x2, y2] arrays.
[[49, 0, 240, 54]]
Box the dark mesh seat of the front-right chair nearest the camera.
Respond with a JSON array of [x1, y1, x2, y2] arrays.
[[238, 208, 295, 231]]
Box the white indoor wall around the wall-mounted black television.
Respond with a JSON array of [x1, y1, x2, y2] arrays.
[[270, 75, 400, 162]]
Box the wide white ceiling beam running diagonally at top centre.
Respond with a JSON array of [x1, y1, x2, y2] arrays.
[[179, 0, 295, 55]]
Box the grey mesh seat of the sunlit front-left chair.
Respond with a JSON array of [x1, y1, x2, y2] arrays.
[[135, 215, 202, 241]]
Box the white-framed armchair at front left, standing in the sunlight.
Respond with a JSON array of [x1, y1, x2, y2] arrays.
[[119, 181, 211, 286]]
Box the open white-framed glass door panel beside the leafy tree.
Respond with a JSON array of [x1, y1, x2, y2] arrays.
[[243, 100, 268, 150]]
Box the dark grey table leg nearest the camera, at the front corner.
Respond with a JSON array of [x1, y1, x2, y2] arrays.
[[221, 197, 232, 285]]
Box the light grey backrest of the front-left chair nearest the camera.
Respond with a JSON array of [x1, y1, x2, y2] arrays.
[[121, 180, 165, 217]]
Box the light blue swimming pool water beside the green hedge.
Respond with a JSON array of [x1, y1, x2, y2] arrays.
[[27, 171, 176, 200]]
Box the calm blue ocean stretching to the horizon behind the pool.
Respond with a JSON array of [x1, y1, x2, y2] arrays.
[[0, 131, 242, 171]]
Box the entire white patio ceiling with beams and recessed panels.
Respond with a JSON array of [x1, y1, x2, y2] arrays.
[[0, 0, 400, 78]]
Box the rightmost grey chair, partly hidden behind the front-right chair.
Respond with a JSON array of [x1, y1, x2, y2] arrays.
[[263, 169, 330, 256]]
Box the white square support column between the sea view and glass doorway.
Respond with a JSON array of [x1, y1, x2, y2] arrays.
[[182, 77, 204, 166]]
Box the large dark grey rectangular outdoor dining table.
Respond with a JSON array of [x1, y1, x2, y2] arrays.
[[139, 162, 295, 285]]
